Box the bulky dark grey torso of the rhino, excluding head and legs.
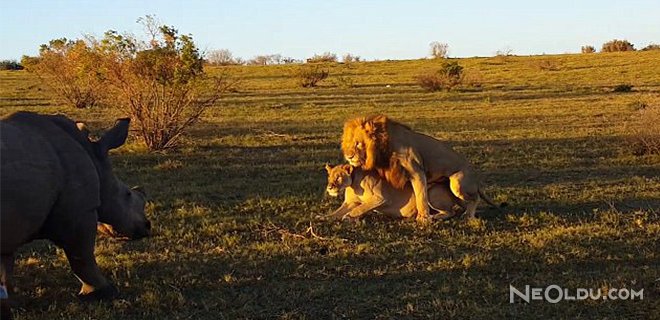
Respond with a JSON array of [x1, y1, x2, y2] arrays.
[[0, 112, 100, 254]]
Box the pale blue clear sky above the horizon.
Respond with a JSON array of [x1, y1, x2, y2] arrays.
[[0, 0, 660, 59]]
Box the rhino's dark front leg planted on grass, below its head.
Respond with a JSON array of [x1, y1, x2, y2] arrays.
[[61, 214, 119, 300]]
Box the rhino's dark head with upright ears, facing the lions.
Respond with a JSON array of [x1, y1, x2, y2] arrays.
[[77, 118, 151, 239]]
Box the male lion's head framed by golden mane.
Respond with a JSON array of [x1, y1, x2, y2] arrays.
[[341, 115, 389, 170]]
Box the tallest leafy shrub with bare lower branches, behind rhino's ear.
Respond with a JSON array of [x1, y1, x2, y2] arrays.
[[96, 16, 230, 151]]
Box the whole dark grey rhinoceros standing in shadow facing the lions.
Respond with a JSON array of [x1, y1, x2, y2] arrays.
[[0, 112, 151, 319]]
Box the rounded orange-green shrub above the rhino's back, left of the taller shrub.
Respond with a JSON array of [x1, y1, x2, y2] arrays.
[[22, 38, 105, 108]]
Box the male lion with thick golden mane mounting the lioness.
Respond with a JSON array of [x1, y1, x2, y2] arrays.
[[341, 115, 497, 222]]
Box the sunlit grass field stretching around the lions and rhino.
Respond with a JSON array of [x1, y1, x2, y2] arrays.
[[0, 51, 660, 319]]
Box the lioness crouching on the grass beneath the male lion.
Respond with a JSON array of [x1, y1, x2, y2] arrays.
[[325, 164, 462, 219]]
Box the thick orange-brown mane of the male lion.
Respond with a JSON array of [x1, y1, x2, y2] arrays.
[[341, 115, 410, 189]]
